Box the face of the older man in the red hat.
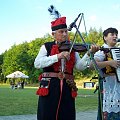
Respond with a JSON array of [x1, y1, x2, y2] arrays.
[[52, 28, 68, 42]]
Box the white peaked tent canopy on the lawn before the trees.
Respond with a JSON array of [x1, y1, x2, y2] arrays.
[[6, 71, 29, 78]]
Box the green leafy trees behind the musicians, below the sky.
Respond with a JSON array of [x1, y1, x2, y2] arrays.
[[0, 28, 103, 83]]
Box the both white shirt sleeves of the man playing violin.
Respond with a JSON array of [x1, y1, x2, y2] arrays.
[[34, 45, 90, 70]]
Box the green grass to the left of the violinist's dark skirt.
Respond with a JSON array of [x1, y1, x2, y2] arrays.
[[0, 86, 38, 115]]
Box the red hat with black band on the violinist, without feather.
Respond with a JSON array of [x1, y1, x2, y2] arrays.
[[51, 17, 67, 31]]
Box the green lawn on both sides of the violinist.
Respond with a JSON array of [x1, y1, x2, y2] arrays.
[[0, 85, 97, 116]]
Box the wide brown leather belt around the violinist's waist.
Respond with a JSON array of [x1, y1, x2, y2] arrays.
[[42, 72, 74, 80]]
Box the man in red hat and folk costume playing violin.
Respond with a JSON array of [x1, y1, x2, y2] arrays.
[[34, 17, 99, 120]]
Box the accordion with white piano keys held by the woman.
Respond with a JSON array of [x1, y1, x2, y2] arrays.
[[110, 48, 120, 82]]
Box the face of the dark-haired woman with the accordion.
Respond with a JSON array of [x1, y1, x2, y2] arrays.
[[104, 33, 118, 47]]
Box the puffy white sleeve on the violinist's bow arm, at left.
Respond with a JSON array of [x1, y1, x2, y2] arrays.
[[34, 45, 58, 69]]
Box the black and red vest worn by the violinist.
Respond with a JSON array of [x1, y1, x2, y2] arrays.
[[43, 41, 75, 74]]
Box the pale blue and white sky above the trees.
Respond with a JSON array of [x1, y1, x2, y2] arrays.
[[0, 0, 120, 54]]
